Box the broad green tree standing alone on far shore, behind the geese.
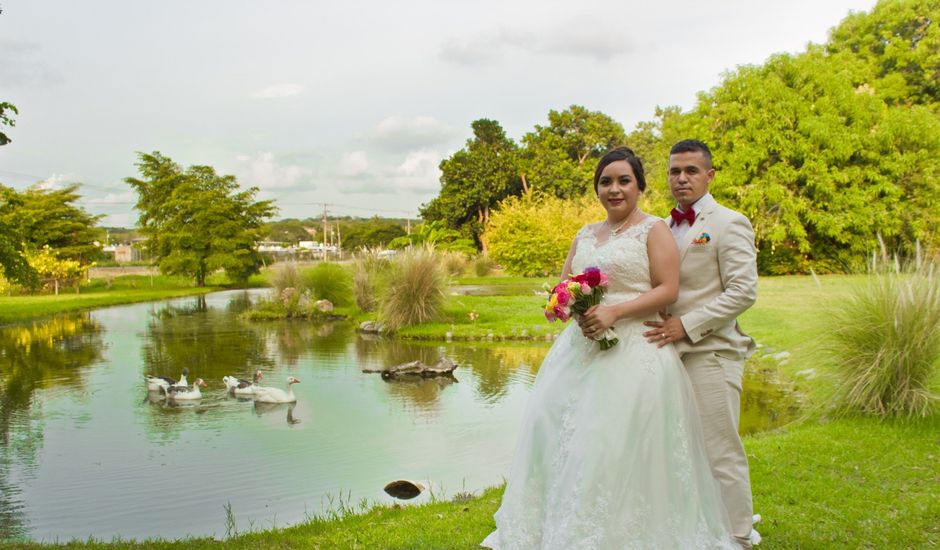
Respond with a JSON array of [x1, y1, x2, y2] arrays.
[[124, 152, 275, 286]]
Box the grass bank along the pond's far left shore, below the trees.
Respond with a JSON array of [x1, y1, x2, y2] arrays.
[[0, 275, 226, 324]]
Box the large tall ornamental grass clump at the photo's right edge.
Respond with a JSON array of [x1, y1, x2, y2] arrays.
[[828, 253, 940, 417]]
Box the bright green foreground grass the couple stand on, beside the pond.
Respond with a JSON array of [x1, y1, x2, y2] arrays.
[[12, 419, 940, 550]]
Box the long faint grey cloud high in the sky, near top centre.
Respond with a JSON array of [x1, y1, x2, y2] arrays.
[[439, 18, 636, 66]]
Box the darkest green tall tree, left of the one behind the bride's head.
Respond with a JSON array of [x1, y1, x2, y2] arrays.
[[421, 122, 522, 251]]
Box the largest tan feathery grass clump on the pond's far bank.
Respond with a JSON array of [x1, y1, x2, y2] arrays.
[[379, 245, 447, 331]]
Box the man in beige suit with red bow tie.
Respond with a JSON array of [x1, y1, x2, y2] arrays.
[[644, 139, 760, 548]]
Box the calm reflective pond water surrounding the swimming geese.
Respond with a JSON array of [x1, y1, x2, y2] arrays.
[[0, 291, 797, 542]]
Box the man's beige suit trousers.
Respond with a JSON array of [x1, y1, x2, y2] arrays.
[[682, 351, 754, 548]]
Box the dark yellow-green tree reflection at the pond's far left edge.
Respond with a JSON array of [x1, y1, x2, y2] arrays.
[[0, 313, 103, 540]]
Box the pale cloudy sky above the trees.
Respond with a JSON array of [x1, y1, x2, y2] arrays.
[[0, 0, 875, 227]]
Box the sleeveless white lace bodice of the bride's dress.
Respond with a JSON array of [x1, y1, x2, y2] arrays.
[[571, 217, 659, 302]]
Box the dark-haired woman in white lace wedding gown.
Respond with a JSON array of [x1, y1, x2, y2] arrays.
[[482, 147, 737, 550]]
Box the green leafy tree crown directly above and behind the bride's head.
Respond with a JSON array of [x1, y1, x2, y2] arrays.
[[519, 105, 626, 198]]
